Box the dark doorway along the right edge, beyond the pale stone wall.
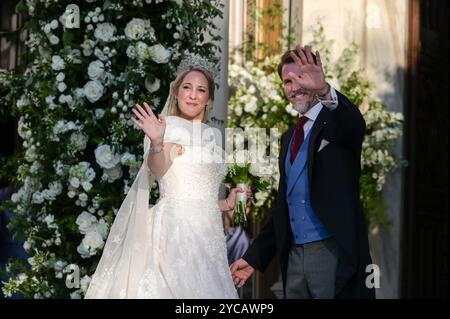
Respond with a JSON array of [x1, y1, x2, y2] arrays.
[[401, 0, 449, 298]]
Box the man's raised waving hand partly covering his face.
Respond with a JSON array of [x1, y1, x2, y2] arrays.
[[288, 45, 328, 96]]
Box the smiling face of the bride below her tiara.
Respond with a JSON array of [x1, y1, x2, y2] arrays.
[[177, 70, 209, 121]]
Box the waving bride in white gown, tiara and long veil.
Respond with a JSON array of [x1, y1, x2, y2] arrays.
[[85, 56, 251, 298]]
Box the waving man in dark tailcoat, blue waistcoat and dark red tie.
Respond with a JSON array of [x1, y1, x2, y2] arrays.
[[230, 46, 375, 298]]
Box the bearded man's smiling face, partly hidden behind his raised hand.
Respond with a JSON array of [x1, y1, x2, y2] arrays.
[[281, 63, 318, 114]]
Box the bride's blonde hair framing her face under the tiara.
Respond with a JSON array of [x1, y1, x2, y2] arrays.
[[167, 68, 215, 122]]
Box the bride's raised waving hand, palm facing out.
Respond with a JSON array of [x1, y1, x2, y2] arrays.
[[131, 102, 166, 143]]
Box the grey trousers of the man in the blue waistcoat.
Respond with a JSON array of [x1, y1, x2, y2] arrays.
[[286, 238, 339, 299]]
